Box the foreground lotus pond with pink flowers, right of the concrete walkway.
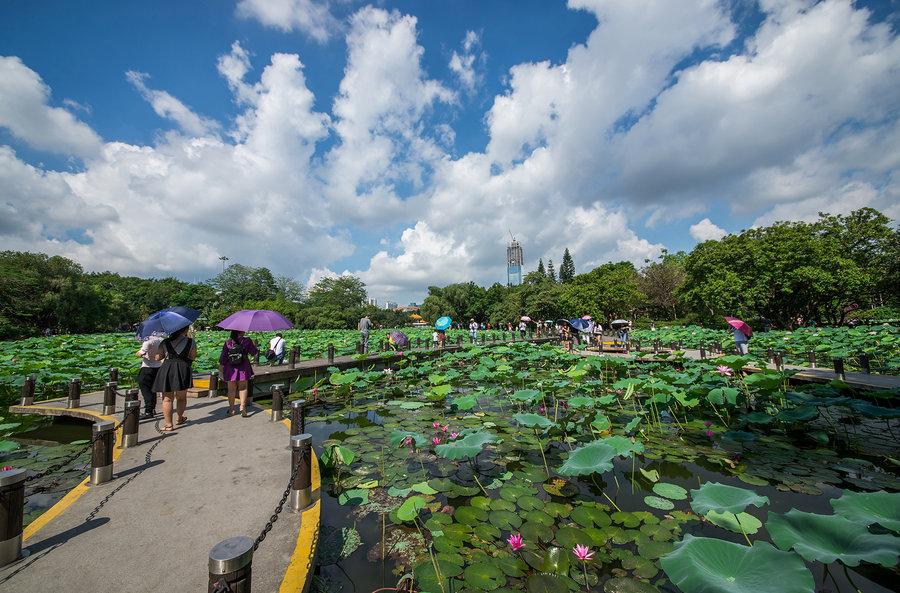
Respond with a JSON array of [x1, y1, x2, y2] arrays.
[[305, 344, 900, 593]]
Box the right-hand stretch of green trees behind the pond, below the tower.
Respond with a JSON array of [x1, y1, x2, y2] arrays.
[[420, 208, 900, 328]]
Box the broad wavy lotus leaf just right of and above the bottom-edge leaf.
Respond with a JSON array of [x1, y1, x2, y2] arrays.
[[766, 509, 900, 568]]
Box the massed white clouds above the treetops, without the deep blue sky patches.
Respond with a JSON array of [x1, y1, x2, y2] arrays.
[[0, 0, 900, 301]]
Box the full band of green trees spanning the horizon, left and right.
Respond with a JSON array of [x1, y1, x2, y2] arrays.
[[0, 208, 900, 339]]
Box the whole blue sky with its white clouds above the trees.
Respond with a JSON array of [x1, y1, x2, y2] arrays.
[[0, 0, 900, 303]]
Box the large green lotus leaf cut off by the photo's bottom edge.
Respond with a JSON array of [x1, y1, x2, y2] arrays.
[[659, 535, 815, 593]]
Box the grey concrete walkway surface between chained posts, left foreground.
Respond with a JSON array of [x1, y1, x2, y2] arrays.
[[0, 394, 310, 593]]
